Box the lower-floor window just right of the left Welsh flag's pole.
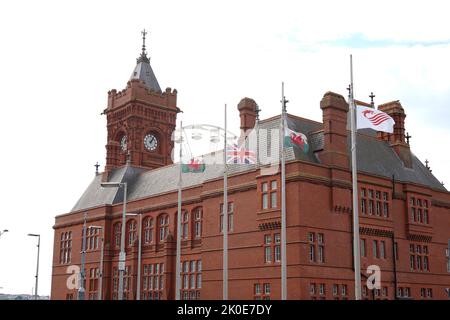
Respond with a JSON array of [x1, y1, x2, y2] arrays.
[[181, 260, 202, 300]]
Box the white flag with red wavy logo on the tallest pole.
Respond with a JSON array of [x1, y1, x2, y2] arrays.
[[356, 105, 395, 133]]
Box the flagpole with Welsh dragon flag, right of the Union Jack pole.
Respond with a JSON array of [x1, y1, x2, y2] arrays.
[[280, 82, 287, 300]]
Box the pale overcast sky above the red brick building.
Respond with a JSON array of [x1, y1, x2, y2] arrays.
[[0, 0, 450, 294]]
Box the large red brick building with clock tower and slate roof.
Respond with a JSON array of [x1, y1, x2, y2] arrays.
[[51, 40, 450, 299]]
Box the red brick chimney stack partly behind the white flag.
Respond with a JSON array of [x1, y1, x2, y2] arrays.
[[377, 100, 412, 168]]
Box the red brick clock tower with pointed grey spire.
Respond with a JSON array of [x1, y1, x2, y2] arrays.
[[104, 30, 180, 172]]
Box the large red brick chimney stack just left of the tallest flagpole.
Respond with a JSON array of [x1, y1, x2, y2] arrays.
[[320, 91, 349, 168]]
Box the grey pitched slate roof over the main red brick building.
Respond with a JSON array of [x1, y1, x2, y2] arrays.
[[72, 115, 446, 211]]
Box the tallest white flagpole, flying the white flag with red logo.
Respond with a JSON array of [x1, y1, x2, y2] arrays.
[[349, 55, 361, 300]]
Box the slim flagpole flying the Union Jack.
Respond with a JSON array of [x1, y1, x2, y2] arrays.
[[222, 104, 228, 300]]
